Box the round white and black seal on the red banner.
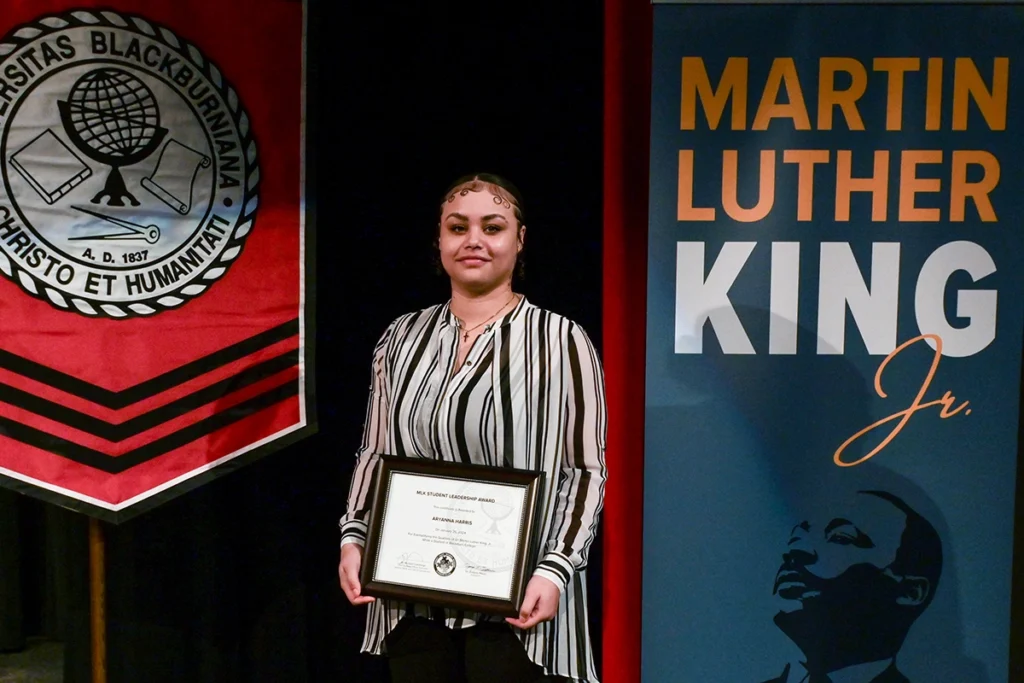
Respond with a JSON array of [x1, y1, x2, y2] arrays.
[[0, 11, 259, 318]]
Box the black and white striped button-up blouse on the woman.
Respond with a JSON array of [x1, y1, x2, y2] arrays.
[[341, 298, 606, 682]]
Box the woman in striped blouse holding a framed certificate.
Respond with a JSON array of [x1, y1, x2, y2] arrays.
[[338, 174, 605, 683]]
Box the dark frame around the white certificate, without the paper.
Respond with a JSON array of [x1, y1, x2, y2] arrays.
[[359, 455, 544, 616]]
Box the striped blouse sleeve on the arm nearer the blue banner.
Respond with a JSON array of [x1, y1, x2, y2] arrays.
[[535, 324, 607, 591]]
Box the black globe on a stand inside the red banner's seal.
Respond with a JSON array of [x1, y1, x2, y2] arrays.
[[57, 67, 167, 206]]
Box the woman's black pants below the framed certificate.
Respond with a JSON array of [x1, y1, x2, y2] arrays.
[[384, 616, 560, 683]]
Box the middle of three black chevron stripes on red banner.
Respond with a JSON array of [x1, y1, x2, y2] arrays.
[[0, 349, 299, 442]]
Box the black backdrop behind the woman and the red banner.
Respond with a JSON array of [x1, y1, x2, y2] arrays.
[[2, 0, 602, 683]]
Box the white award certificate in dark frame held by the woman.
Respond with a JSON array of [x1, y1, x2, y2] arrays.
[[360, 456, 544, 616]]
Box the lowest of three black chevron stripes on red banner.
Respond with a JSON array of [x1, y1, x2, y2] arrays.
[[0, 380, 299, 474]]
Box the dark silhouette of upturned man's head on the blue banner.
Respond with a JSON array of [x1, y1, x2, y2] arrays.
[[766, 490, 942, 683]]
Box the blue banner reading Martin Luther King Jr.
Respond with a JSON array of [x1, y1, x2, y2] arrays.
[[642, 4, 1024, 683]]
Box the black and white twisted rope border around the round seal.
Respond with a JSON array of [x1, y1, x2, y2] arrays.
[[0, 9, 259, 319]]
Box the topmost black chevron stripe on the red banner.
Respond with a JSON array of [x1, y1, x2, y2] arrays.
[[0, 318, 299, 410]]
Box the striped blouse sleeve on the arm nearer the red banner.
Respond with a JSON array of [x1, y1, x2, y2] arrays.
[[339, 324, 395, 546]]
